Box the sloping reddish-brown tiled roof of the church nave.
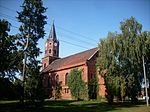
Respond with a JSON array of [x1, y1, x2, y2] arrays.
[[42, 48, 98, 72]]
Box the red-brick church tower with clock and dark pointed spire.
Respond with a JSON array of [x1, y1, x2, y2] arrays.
[[42, 21, 59, 69]]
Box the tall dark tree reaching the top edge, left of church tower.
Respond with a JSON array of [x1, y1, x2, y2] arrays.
[[17, 0, 46, 105]]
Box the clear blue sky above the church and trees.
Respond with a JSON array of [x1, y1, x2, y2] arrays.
[[0, 0, 150, 59]]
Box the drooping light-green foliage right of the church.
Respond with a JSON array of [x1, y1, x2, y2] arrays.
[[97, 17, 150, 103]]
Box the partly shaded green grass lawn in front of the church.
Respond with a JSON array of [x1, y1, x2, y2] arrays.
[[0, 100, 150, 112]]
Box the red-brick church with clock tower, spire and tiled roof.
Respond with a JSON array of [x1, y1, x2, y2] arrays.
[[41, 22, 105, 99]]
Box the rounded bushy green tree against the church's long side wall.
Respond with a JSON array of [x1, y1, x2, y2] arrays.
[[68, 69, 86, 100]]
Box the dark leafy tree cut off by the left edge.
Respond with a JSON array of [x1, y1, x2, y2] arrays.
[[0, 20, 19, 79]]
